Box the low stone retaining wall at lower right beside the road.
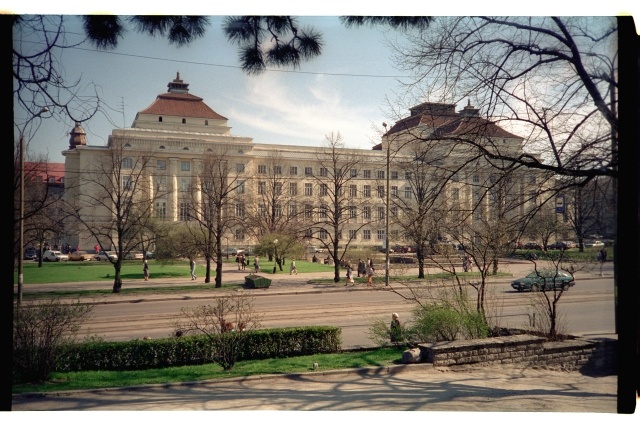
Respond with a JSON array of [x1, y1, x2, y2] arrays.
[[418, 334, 617, 374]]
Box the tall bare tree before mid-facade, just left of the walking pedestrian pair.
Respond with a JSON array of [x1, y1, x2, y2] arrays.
[[303, 133, 371, 282]]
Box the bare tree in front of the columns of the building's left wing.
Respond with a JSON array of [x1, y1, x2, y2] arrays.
[[67, 138, 161, 293]]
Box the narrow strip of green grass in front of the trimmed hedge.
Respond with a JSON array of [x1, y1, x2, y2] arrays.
[[13, 347, 404, 393]]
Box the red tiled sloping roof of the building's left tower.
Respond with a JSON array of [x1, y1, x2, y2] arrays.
[[140, 93, 227, 121]]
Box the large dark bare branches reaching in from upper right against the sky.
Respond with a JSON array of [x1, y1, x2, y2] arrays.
[[398, 17, 618, 183]]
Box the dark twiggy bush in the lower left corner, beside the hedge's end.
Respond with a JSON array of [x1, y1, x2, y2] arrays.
[[13, 299, 92, 383]]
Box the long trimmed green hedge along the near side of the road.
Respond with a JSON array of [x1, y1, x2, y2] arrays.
[[56, 327, 342, 372]]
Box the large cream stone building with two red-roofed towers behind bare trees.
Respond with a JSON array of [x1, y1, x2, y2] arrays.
[[63, 74, 539, 253]]
